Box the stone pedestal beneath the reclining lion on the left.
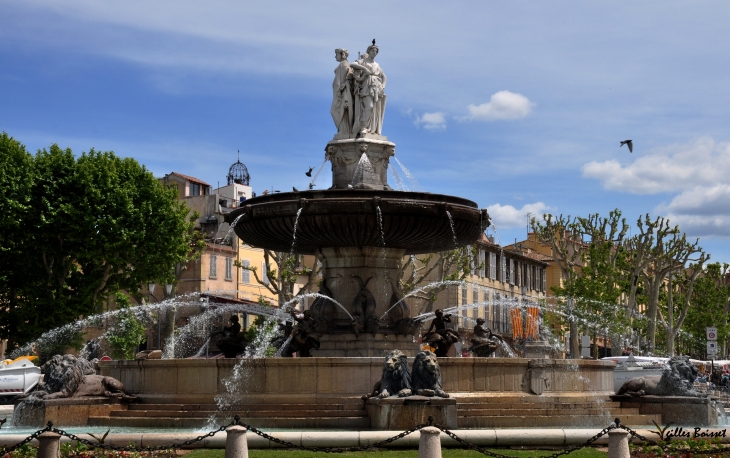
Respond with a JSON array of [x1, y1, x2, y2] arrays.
[[13, 396, 127, 428]]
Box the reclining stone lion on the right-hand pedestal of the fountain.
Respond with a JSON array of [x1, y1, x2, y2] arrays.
[[616, 356, 700, 396]]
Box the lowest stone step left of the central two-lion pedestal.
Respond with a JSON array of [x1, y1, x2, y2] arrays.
[[88, 416, 370, 430]]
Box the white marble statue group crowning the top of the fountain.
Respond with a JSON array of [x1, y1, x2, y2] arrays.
[[330, 40, 386, 135]]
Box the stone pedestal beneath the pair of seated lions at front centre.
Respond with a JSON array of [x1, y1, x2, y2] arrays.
[[365, 396, 458, 431]]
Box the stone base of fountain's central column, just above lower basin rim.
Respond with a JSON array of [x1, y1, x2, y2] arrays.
[[312, 334, 420, 357]]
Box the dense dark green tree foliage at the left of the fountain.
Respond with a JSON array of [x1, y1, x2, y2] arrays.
[[0, 134, 199, 348]]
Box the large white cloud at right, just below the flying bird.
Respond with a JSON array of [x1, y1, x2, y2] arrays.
[[582, 138, 730, 194]]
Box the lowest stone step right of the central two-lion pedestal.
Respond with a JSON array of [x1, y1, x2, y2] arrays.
[[458, 414, 661, 429]]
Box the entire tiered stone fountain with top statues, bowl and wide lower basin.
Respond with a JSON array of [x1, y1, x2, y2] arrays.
[[11, 44, 636, 429]]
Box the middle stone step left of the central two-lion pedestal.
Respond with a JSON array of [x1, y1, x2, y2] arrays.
[[109, 409, 367, 418]]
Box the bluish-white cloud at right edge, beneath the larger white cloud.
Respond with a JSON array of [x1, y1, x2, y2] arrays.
[[656, 184, 730, 237]]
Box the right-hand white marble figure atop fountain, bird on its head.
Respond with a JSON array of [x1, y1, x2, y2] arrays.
[[352, 40, 386, 135]]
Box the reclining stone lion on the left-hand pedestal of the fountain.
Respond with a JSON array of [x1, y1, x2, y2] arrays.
[[23, 355, 136, 400]]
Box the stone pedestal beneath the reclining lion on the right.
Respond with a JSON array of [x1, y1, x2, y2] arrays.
[[610, 395, 724, 427]]
